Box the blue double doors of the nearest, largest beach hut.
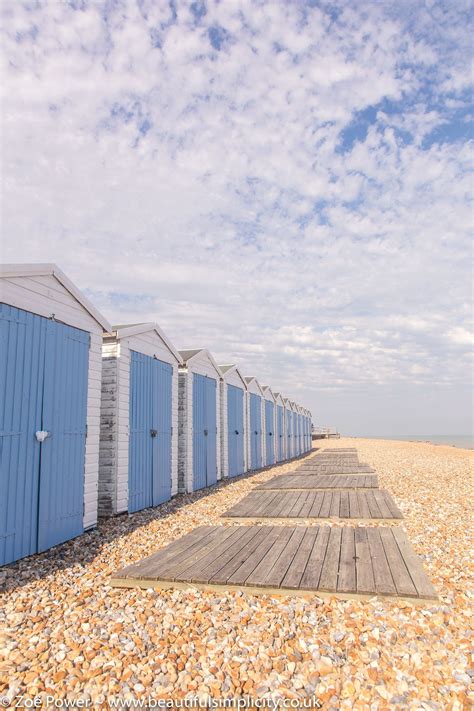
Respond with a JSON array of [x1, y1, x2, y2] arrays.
[[0, 304, 89, 565]]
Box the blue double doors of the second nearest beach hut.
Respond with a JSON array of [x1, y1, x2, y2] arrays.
[[128, 351, 173, 512]]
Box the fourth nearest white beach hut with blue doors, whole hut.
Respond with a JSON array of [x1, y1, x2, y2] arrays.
[[219, 365, 248, 478]]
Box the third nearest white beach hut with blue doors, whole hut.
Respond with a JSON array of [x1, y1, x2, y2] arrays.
[[178, 348, 221, 492]]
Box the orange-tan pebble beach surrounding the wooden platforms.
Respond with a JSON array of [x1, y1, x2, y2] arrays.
[[0, 438, 474, 711]]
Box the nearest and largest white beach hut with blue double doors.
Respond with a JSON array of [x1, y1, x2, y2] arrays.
[[0, 264, 110, 565]]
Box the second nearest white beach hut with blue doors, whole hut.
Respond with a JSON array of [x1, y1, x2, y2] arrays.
[[99, 323, 181, 516]]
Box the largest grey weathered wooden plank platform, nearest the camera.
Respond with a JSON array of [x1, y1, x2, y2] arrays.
[[111, 526, 437, 602]]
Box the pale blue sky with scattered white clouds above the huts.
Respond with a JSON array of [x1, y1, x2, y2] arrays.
[[1, 0, 474, 436]]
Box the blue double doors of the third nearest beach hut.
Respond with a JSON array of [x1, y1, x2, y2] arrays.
[[193, 373, 217, 491]]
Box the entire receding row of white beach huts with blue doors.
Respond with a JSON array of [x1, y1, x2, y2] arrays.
[[0, 264, 311, 565]]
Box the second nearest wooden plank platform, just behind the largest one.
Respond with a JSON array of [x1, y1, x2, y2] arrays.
[[223, 489, 403, 522]]
